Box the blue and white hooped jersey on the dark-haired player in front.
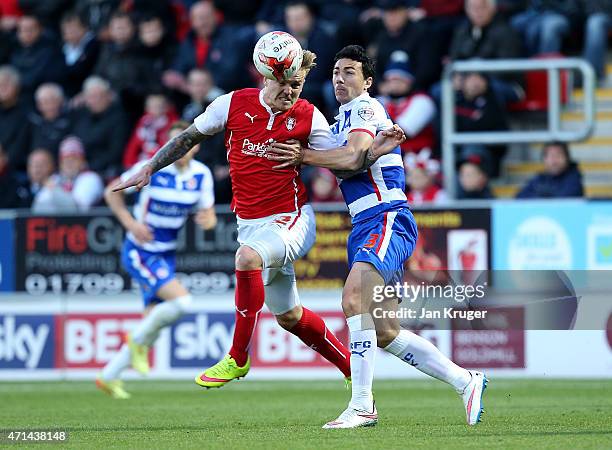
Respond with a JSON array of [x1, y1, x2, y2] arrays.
[[331, 92, 408, 222]]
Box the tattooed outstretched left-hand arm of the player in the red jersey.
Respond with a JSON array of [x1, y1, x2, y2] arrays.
[[113, 124, 209, 192]]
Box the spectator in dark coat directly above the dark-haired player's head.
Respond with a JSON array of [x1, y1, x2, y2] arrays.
[[369, 0, 442, 90]]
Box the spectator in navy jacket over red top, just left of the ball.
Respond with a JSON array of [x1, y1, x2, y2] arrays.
[[163, 1, 252, 92]]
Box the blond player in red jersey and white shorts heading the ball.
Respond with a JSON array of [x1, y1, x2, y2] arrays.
[[115, 47, 404, 387]]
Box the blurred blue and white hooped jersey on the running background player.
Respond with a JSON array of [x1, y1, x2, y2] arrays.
[[121, 160, 215, 253]]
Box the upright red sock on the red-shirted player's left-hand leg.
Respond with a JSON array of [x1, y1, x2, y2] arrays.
[[229, 269, 265, 367]]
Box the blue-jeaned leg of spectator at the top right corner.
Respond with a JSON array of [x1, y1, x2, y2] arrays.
[[584, 0, 612, 81]]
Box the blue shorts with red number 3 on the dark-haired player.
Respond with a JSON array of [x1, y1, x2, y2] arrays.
[[347, 208, 418, 284]]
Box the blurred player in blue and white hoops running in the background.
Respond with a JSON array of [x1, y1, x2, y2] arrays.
[[96, 122, 217, 399]]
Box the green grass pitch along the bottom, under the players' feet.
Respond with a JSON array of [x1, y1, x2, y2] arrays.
[[0, 379, 612, 450]]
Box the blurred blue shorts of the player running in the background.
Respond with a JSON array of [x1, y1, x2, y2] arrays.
[[121, 239, 176, 306]]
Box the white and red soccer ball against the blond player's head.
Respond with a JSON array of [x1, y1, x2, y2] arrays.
[[253, 31, 303, 81]]
